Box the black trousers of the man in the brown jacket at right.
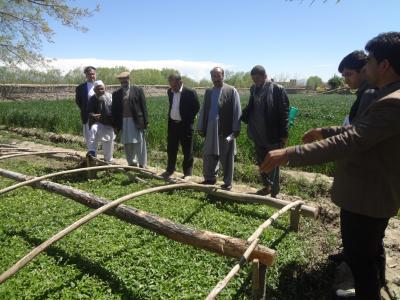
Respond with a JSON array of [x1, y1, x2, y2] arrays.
[[340, 209, 389, 300]]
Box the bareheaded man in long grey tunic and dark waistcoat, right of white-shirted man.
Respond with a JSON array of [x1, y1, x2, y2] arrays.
[[198, 67, 242, 190]]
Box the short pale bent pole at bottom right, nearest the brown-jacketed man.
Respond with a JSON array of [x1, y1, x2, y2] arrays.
[[206, 200, 304, 300]]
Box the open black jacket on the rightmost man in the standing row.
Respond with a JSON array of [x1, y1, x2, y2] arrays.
[[242, 83, 289, 144]]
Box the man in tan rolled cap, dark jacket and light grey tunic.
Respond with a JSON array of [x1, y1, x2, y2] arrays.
[[112, 72, 149, 168]]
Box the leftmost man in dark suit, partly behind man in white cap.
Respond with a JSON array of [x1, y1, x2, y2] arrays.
[[75, 66, 96, 151]]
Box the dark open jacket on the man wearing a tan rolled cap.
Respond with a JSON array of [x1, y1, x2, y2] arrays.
[[111, 85, 149, 130]]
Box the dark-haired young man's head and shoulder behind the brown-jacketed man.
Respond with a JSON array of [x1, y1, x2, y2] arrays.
[[338, 50, 376, 125]]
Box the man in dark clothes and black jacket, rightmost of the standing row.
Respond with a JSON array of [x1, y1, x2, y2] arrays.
[[242, 65, 289, 197]]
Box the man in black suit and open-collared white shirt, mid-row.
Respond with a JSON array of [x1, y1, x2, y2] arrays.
[[163, 74, 200, 177]]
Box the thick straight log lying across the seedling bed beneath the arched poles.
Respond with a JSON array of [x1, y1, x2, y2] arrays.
[[0, 169, 276, 284]]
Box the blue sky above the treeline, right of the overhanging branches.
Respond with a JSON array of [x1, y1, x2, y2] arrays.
[[42, 0, 400, 81]]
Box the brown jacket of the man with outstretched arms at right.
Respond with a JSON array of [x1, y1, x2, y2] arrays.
[[287, 82, 400, 218]]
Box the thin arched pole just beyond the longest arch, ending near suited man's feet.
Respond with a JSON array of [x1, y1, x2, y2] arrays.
[[0, 165, 159, 195]]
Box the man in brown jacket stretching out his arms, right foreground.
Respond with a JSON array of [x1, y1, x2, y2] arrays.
[[260, 32, 400, 300]]
